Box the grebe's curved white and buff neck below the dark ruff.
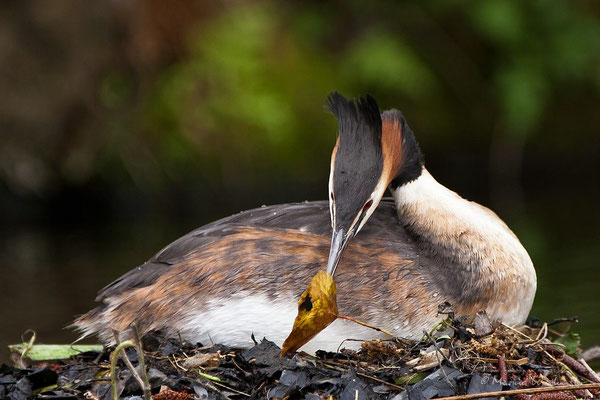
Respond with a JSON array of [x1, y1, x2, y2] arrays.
[[393, 168, 536, 323]]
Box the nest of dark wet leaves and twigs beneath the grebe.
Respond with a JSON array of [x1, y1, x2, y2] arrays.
[[0, 313, 600, 400]]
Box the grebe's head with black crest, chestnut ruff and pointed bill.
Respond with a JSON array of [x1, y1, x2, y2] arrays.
[[327, 92, 423, 275]]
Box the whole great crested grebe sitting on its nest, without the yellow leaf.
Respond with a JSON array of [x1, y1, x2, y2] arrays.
[[74, 93, 536, 352]]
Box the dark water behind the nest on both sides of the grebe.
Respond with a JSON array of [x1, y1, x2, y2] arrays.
[[0, 188, 600, 361]]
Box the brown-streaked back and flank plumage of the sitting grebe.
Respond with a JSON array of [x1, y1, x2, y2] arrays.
[[75, 200, 451, 340]]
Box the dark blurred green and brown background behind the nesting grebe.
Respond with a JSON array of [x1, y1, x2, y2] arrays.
[[0, 0, 600, 358]]
